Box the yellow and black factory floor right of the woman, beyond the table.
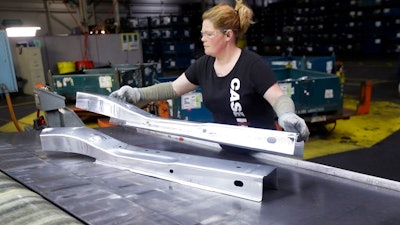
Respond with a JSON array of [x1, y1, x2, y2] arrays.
[[308, 59, 400, 181]]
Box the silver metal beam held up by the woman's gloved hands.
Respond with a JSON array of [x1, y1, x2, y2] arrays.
[[76, 92, 304, 157]]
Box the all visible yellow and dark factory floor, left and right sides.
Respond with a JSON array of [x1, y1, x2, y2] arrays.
[[0, 58, 400, 181]]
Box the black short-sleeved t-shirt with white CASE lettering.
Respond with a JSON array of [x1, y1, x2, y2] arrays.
[[185, 50, 276, 129]]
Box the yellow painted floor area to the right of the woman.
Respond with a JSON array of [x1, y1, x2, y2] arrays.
[[304, 99, 400, 159]]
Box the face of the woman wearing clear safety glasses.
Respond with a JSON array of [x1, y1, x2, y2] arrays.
[[201, 20, 225, 57]]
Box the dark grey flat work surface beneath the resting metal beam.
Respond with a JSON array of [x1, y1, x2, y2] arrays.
[[0, 127, 400, 225]]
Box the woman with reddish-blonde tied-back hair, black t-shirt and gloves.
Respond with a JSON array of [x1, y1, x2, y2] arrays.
[[111, 0, 310, 151]]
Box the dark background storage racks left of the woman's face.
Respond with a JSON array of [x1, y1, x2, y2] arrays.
[[132, 2, 201, 75]]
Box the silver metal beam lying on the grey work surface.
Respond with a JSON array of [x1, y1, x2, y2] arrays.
[[40, 127, 277, 201]]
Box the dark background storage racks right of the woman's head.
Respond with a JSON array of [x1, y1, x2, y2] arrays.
[[247, 0, 400, 55]]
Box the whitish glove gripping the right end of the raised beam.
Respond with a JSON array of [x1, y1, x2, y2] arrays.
[[278, 112, 310, 141]]
